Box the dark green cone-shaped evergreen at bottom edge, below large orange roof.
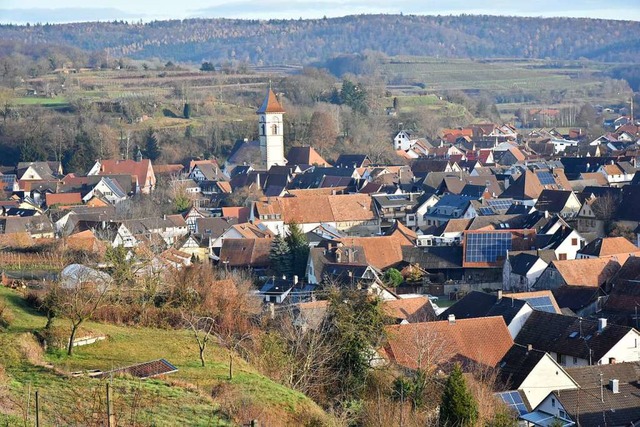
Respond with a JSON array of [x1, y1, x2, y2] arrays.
[[440, 364, 478, 427]]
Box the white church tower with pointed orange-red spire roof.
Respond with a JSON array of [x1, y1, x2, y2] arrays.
[[256, 87, 287, 170]]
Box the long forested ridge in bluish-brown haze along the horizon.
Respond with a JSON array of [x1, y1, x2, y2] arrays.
[[0, 15, 640, 65]]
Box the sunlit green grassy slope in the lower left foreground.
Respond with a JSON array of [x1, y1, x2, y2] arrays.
[[0, 287, 327, 426]]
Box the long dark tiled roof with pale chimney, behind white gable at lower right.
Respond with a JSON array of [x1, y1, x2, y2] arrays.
[[515, 310, 632, 363]]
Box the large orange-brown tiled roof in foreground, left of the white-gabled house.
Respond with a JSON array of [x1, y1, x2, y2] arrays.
[[380, 317, 513, 369]]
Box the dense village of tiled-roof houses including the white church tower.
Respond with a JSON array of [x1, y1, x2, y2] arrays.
[[0, 89, 640, 426]]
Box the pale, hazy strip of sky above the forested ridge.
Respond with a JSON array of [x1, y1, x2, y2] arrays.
[[0, 0, 640, 24]]
